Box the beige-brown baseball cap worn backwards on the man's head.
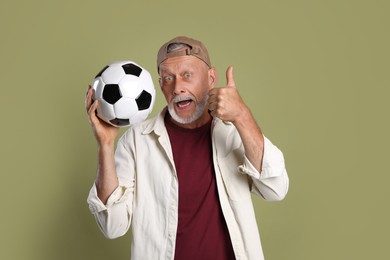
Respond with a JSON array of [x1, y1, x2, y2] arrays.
[[157, 36, 211, 71]]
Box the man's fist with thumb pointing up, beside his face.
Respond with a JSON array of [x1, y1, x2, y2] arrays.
[[209, 66, 247, 123]]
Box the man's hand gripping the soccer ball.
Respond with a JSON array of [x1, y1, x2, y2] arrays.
[[85, 86, 119, 147]]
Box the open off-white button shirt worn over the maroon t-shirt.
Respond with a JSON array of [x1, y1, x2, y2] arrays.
[[87, 110, 289, 260]]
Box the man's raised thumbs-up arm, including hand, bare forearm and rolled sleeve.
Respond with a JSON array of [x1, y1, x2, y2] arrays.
[[209, 67, 289, 200]]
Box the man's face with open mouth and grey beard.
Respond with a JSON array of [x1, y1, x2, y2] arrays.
[[159, 56, 216, 127]]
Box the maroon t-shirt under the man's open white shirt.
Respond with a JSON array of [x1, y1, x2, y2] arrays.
[[165, 115, 235, 260]]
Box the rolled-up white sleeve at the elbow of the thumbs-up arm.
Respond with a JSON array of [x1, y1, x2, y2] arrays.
[[239, 136, 289, 200]]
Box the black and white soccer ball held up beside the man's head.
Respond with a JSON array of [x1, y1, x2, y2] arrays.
[[92, 61, 156, 127]]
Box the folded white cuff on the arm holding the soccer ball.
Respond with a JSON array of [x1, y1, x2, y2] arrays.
[[87, 184, 128, 214]]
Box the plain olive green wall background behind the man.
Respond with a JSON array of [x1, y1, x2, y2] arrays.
[[0, 0, 390, 260]]
